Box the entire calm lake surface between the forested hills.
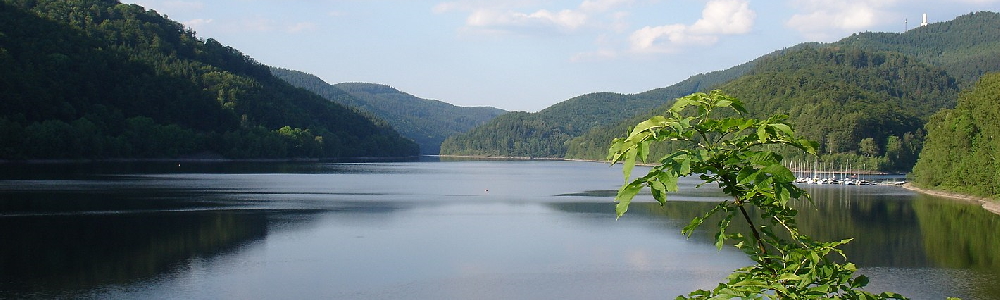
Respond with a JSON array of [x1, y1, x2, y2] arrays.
[[0, 158, 1000, 299]]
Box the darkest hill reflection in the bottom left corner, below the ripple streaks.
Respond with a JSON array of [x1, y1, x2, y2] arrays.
[[0, 211, 268, 298]]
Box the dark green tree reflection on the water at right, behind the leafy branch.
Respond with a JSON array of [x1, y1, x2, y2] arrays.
[[551, 186, 1000, 270]]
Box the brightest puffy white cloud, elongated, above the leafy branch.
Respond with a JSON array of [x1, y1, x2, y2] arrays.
[[629, 0, 757, 53]]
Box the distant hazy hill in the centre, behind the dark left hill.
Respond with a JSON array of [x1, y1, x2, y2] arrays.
[[271, 68, 506, 154]]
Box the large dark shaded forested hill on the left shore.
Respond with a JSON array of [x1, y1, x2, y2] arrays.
[[0, 0, 418, 159]]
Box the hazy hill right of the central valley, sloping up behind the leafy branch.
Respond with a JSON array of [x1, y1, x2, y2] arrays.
[[441, 57, 754, 158]]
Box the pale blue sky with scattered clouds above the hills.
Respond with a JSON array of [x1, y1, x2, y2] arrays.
[[122, 0, 1000, 112]]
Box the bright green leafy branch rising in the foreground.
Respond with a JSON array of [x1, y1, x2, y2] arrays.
[[608, 90, 906, 299]]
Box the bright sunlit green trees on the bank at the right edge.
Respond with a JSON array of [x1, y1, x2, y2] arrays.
[[912, 73, 1000, 198]]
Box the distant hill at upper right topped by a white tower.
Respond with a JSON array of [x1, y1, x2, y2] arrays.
[[832, 11, 1000, 87]]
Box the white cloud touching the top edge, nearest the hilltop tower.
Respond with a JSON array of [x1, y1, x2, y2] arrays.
[[785, 0, 897, 41]]
